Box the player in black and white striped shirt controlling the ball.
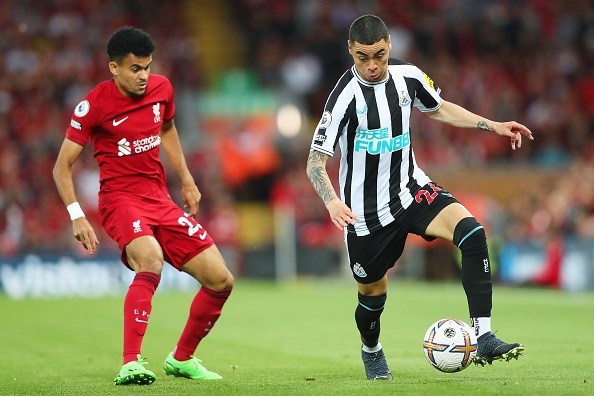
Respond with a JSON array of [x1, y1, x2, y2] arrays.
[[307, 15, 533, 380]]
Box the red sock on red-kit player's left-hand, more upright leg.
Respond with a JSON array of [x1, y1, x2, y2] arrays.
[[123, 272, 161, 364]]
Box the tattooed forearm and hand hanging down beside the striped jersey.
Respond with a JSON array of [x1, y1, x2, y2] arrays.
[[307, 150, 357, 229]]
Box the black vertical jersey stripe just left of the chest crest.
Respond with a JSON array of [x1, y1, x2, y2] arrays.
[[386, 76, 404, 218]]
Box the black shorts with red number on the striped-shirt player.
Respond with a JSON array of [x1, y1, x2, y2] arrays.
[[346, 183, 458, 284]]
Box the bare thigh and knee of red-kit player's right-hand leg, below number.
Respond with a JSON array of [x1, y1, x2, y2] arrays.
[[181, 244, 234, 291]]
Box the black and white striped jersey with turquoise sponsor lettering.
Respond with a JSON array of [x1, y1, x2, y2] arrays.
[[311, 59, 441, 235]]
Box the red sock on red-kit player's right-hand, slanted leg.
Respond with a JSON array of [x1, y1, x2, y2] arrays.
[[173, 287, 231, 361]]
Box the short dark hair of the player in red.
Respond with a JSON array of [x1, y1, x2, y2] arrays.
[[107, 26, 155, 63]]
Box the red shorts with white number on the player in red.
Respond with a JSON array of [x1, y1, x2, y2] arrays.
[[99, 191, 214, 271]]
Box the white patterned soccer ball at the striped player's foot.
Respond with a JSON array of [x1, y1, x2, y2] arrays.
[[423, 318, 477, 373]]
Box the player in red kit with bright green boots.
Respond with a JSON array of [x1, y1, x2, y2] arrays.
[[53, 27, 234, 385]]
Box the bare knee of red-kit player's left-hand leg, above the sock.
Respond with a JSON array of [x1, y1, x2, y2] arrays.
[[124, 235, 163, 274]]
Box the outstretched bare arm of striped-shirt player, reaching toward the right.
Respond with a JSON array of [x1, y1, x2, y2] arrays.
[[427, 100, 534, 150]]
